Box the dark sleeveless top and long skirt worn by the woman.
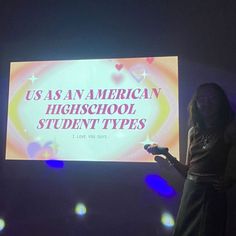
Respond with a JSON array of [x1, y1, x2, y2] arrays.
[[174, 127, 230, 236]]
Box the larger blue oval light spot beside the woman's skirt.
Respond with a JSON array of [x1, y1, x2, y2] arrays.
[[145, 174, 176, 197]]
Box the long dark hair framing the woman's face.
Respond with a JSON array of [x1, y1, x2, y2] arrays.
[[188, 83, 234, 130]]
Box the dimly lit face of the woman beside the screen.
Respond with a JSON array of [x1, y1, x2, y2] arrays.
[[196, 86, 220, 118]]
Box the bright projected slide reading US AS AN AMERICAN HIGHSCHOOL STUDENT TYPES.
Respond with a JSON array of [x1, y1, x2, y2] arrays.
[[5, 56, 179, 162]]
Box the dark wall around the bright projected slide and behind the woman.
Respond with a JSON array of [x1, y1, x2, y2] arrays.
[[0, 0, 236, 236]]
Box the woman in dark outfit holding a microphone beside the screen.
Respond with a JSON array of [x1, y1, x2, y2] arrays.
[[147, 83, 236, 236]]
